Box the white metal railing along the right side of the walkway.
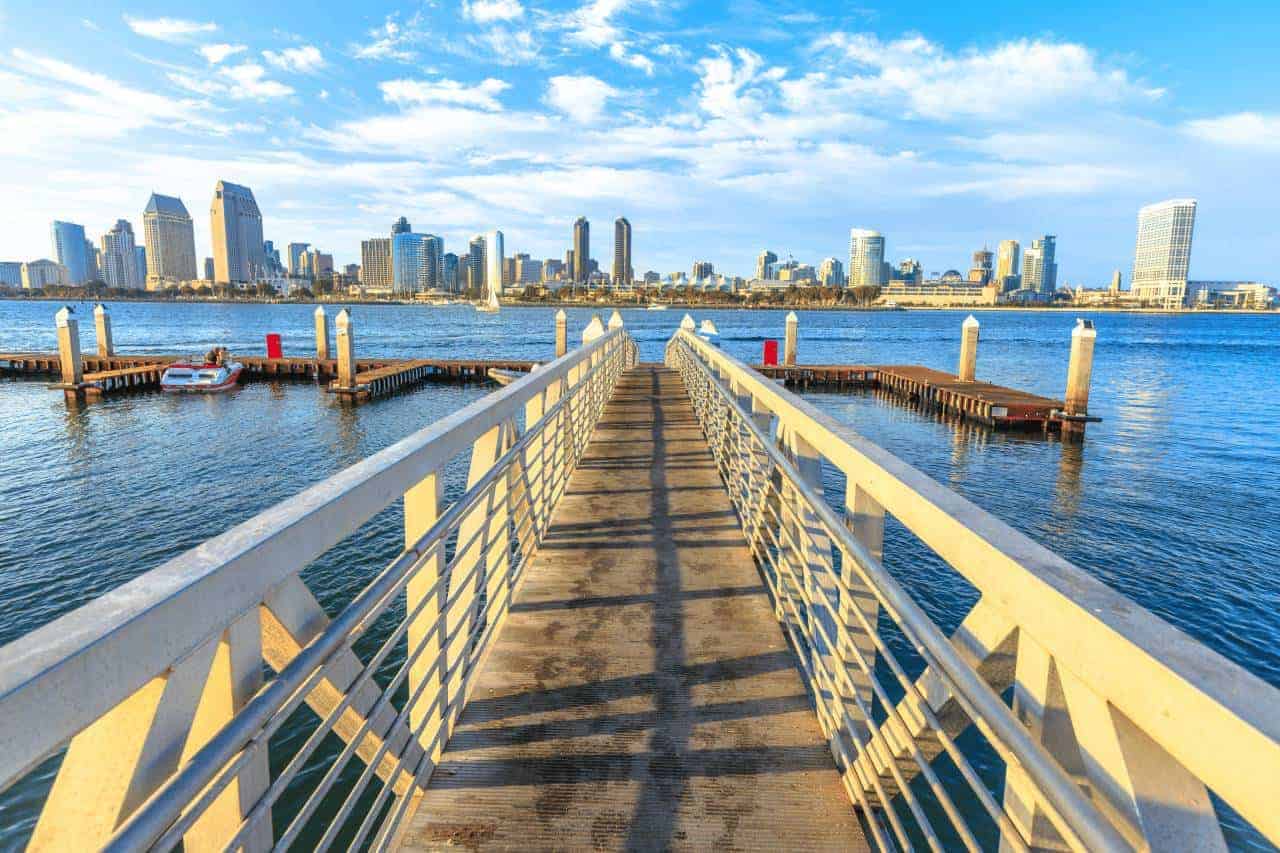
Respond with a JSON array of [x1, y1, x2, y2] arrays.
[[667, 330, 1280, 850]]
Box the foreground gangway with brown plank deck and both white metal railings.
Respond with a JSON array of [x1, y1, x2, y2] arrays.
[[0, 324, 1280, 850]]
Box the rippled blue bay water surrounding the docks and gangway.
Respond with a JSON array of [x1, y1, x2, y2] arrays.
[[0, 302, 1280, 849]]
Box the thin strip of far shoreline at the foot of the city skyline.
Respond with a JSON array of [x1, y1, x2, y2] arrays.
[[0, 296, 1280, 316]]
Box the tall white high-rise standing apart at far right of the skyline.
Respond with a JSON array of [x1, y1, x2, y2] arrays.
[[1129, 199, 1196, 309]]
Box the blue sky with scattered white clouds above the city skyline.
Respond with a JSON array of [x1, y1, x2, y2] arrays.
[[0, 0, 1280, 286]]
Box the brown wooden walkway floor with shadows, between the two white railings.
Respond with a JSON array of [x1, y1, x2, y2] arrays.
[[402, 366, 867, 850]]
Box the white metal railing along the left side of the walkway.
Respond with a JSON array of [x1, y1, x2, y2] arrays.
[[0, 328, 636, 850]]
